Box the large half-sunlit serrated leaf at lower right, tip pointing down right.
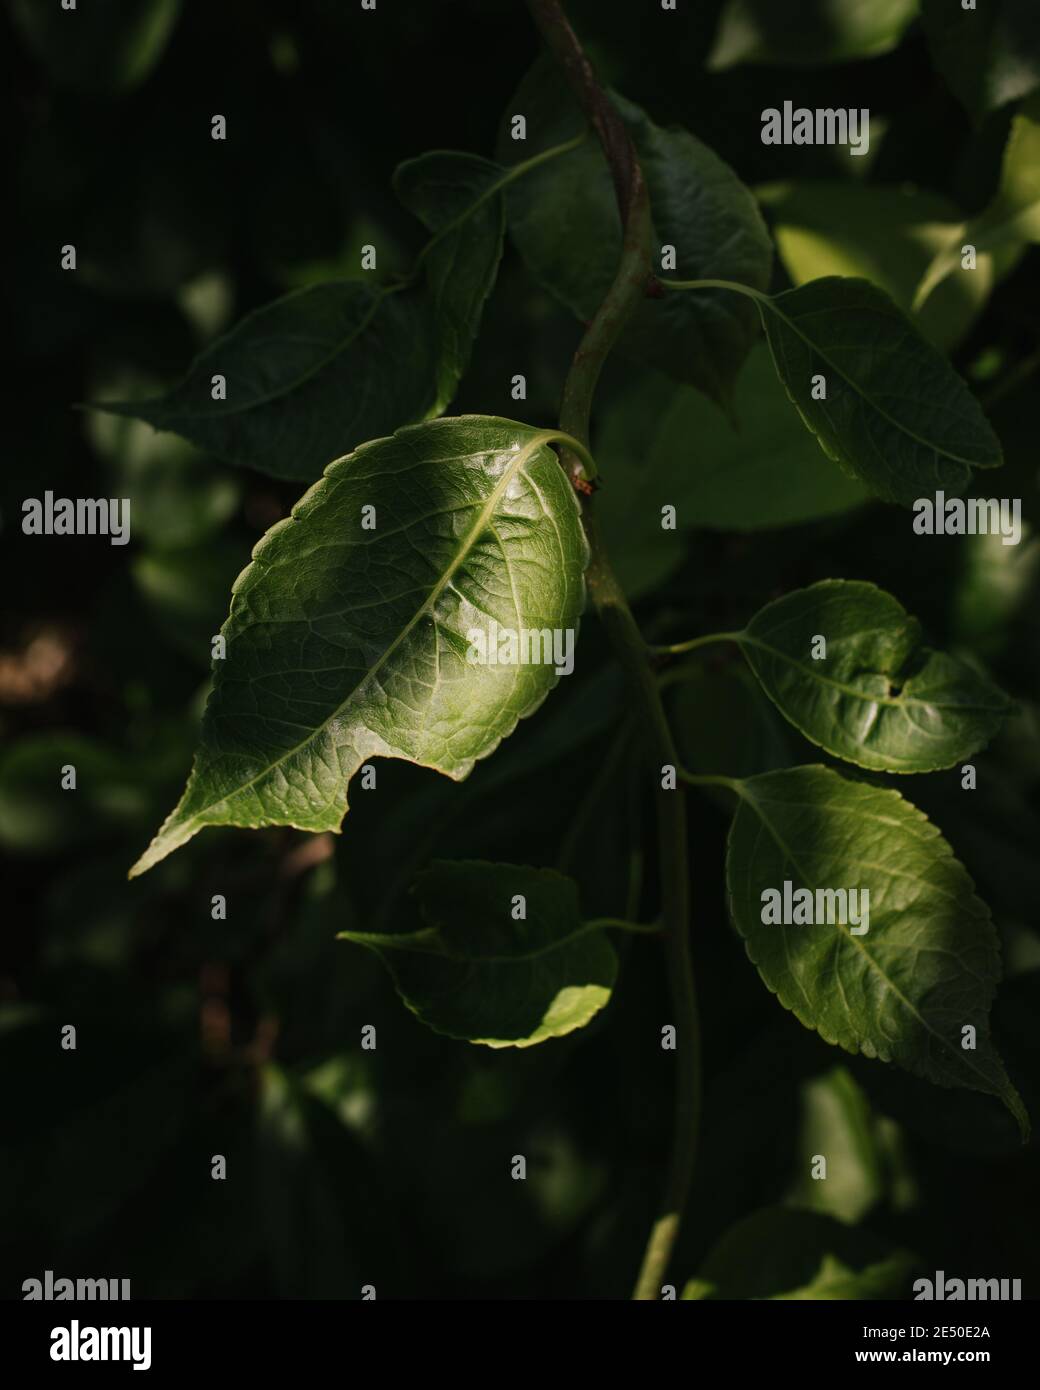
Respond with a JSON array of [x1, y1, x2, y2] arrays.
[[726, 766, 1029, 1136]]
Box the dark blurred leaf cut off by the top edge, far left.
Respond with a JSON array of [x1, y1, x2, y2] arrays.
[[10, 0, 181, 93]]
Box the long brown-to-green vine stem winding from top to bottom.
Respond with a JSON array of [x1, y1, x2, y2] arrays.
[[527, 0, 701, 1300]]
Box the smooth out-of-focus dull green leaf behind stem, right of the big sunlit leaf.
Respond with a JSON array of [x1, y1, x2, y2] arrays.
[[595, 343, 869, 598]]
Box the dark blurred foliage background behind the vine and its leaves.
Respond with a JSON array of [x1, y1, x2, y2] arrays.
[[0, 0, 1040, 1298]]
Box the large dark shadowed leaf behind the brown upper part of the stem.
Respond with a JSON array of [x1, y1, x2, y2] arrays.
[[498, 61, 773, 403]]
